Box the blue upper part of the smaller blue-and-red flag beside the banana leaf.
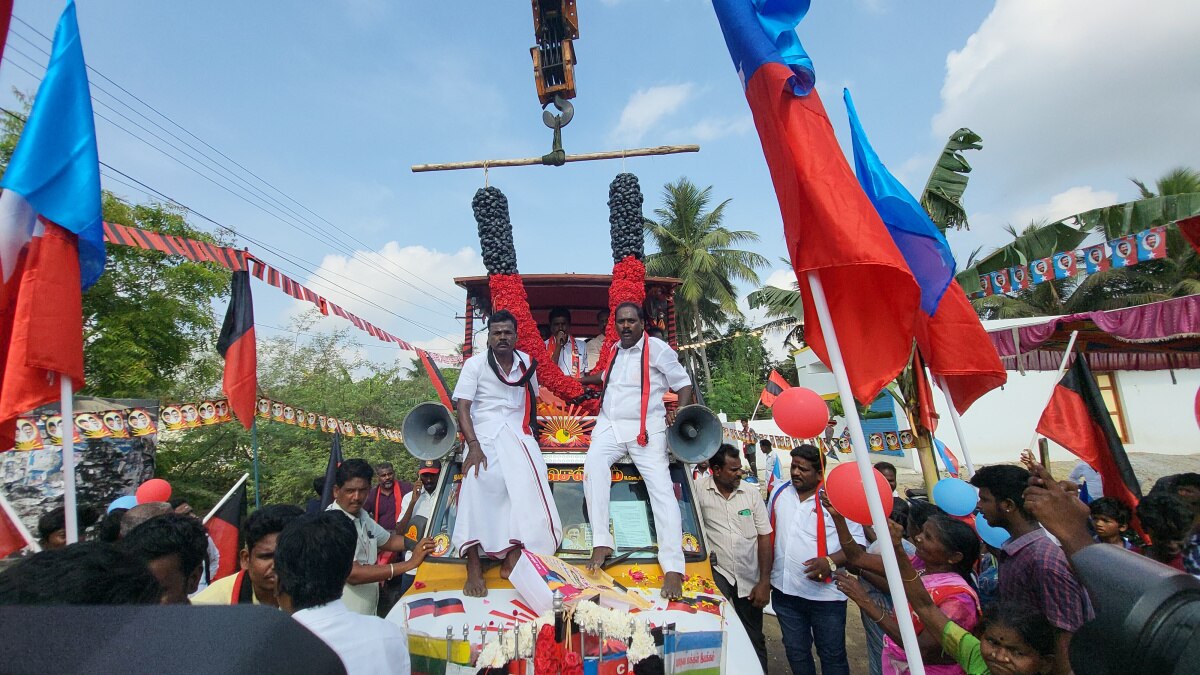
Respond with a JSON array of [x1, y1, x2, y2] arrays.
[[842, 89, 954, 315]]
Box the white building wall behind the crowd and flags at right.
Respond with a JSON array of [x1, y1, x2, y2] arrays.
[[934, 370, 1200, 465]]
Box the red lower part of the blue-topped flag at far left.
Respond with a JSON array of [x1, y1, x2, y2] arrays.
[[0, 218, 83, 448]]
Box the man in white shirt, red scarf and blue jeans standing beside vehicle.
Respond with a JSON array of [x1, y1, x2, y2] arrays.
[[767, 443, 866, 675]]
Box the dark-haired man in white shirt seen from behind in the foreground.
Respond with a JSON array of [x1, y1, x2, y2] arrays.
[[275, 510, 410, 675]]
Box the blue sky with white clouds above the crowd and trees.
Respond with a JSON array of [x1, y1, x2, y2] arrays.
[[0, 0, 1200, 360]]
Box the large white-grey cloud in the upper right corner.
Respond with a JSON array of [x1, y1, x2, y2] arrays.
[[932, 0, 1200, 196]]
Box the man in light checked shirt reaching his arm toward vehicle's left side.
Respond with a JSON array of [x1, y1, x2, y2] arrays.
[[325, 459, 433, 616]]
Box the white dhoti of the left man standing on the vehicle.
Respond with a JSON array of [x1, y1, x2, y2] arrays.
[[452, 424, 563, 558]]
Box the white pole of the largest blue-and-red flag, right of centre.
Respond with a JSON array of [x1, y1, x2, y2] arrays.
[[808, 271, 925, 675]]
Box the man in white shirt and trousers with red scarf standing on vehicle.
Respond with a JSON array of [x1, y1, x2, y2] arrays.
[[583, 303, 691, 598]]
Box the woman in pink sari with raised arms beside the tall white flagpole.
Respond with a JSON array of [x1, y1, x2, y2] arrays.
[[826, 497, 979, 675]]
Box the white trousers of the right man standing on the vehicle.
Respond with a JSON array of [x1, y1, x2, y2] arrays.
[[583, 428, 684, 574]]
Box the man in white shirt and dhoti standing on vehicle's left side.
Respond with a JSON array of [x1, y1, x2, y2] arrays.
[[451, 310, 561, 597]]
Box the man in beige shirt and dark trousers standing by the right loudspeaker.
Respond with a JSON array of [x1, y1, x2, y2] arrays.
[[696, 443, 775, 673]]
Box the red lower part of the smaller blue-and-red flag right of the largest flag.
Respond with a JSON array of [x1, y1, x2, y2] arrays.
[[917, 281, 1008, 414]]
